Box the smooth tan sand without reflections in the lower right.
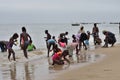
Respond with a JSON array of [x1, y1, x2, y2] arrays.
[[54, 44, 120, 80]]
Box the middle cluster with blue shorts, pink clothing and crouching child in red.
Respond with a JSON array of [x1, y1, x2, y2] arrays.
[[45, 30, 70, 65]]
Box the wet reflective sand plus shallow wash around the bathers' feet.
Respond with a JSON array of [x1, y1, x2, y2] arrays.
[[0, 47, 104, 80]]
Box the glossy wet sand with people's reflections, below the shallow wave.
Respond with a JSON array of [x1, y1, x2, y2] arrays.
[[0, 48, 105, 80]]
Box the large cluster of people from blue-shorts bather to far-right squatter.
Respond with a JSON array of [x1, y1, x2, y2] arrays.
[[45, 23, 116, 64]]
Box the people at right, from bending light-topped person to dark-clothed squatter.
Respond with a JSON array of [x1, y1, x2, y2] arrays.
[[78, 23, 116, 49]]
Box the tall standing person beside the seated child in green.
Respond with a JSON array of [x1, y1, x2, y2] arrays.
[[20, 27, 32, 58]]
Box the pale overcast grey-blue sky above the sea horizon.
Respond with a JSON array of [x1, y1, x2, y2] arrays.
[[0, 0, 120, 24]]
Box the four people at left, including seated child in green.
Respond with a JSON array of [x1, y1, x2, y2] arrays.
[[0, 27, 36, 61]]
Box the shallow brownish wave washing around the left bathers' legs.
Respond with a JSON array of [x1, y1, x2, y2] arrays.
[[0, 49, 44, 65]]
